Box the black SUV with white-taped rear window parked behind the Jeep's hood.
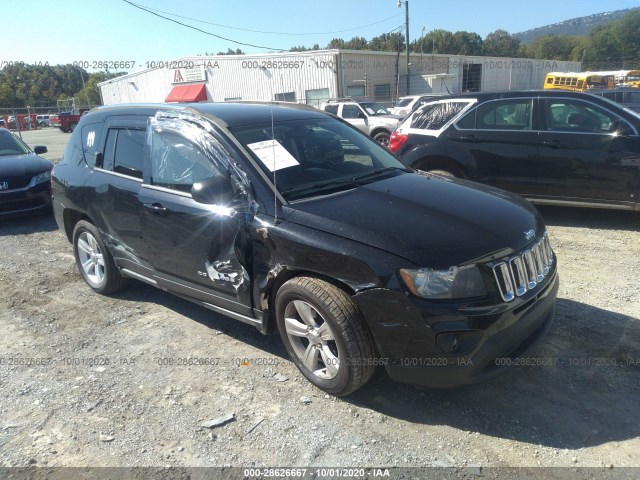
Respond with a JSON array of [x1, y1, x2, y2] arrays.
[[389, 90, 640, 210]]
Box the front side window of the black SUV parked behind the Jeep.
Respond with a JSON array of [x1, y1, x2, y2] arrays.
[[543, 99, 619, 133]]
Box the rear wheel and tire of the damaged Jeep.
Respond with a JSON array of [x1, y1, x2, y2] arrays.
[[73, 220, 127, 295]]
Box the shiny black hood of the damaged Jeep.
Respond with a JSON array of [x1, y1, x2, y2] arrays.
[[284, 173, 544, 268]]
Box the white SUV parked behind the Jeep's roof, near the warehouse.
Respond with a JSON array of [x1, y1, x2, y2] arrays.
[[320, 98, 402, 146]]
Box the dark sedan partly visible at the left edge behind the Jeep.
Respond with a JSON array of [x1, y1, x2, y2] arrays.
[[0, 128, 53, 218]]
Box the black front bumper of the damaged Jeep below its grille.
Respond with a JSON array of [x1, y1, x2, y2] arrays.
[[353, 271, 559, 388]]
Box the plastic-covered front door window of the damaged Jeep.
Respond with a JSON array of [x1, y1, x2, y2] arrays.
[[151, 131, 219, 192]]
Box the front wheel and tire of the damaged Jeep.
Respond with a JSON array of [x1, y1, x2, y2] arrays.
[[275, 277, 375, 396]]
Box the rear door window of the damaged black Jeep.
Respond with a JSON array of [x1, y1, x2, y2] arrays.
[[103, 128, 147, 179]]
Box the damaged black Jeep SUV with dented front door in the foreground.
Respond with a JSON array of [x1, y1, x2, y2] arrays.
[[52, 103, 558, 395]]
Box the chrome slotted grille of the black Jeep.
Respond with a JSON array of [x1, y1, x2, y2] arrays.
[[493, 232, 553, 302]]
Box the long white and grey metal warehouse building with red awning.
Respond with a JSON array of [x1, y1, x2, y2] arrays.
[[99, 50, 581, 105]]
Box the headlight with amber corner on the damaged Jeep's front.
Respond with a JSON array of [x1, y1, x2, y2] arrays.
[[400, 265, 487, 299]]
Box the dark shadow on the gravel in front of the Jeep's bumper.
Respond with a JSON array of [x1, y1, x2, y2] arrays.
[[349, 299, 640, 449]]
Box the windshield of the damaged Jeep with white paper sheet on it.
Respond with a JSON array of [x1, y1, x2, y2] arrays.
[[231, 118, 410, 200]]
